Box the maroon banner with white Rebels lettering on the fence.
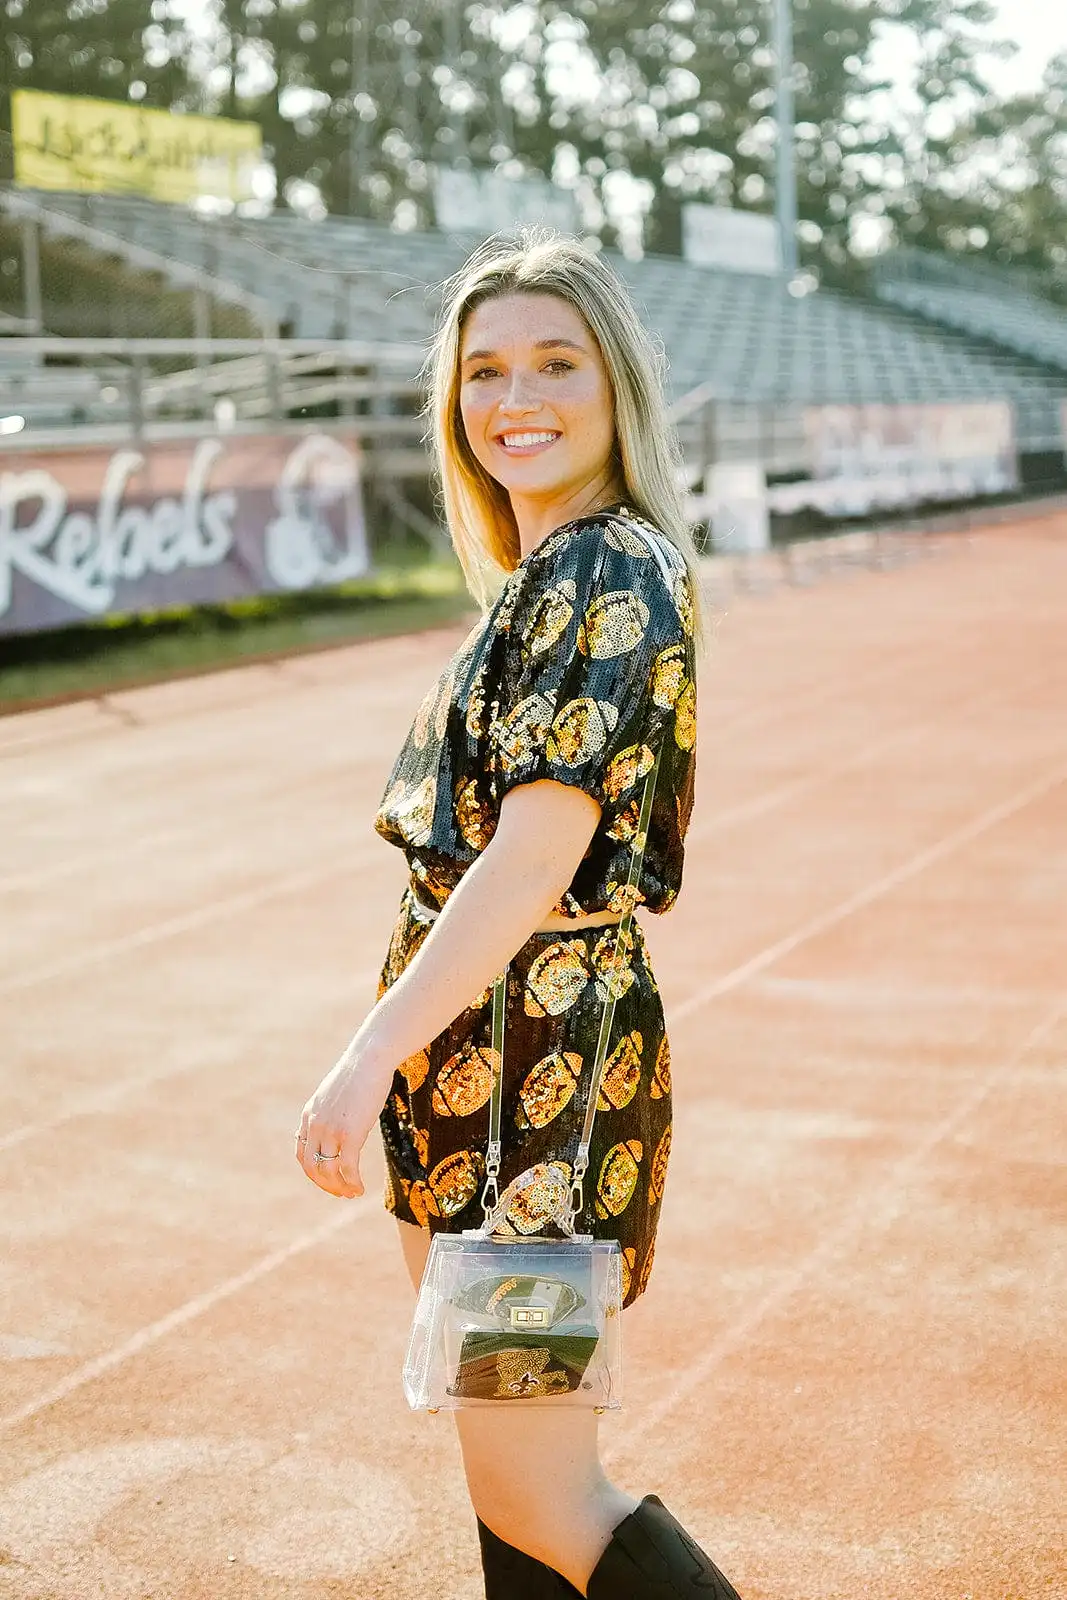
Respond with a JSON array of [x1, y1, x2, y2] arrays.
[[0, 432, 370, 635]]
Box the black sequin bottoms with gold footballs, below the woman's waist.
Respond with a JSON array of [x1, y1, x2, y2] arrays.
[[378, 885, 672, 1306]]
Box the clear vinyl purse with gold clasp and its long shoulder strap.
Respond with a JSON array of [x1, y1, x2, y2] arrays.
[[403, 744, 662, 1411]]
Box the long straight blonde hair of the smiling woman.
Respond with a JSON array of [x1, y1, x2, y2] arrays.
[[422, 229, 709, 651]]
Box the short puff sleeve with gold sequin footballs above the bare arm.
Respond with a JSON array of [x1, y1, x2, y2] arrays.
[[490, 523, 694, 808]]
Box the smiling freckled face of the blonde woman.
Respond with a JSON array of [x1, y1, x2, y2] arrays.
[[459, 293, 616, 521]]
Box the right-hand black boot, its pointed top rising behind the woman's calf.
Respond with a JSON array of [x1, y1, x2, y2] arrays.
[[585, 1494, 741, 1600]]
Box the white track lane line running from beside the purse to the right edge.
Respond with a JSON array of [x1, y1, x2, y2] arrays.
[[608, 997, 1067, 1461]]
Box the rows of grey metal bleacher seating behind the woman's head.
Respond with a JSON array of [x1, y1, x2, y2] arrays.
[[0, 190, 1067, 470]]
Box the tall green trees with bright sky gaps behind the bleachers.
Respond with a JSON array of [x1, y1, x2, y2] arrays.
[[0, 0, 1067, 299]]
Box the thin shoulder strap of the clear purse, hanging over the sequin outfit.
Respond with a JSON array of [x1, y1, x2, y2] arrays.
[[482, 520, 672, 1222]]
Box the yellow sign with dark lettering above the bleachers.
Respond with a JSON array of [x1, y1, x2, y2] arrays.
[[11, 90, 262, 203]]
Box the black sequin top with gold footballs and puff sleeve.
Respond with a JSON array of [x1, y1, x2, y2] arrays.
[[374, 506, 696, 917]]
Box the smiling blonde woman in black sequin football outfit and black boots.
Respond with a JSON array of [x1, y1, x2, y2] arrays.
[[296, 234, 737, 1600]]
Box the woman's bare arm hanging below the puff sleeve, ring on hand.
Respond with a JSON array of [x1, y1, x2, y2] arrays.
[[296, 779, 600, 1197]]
